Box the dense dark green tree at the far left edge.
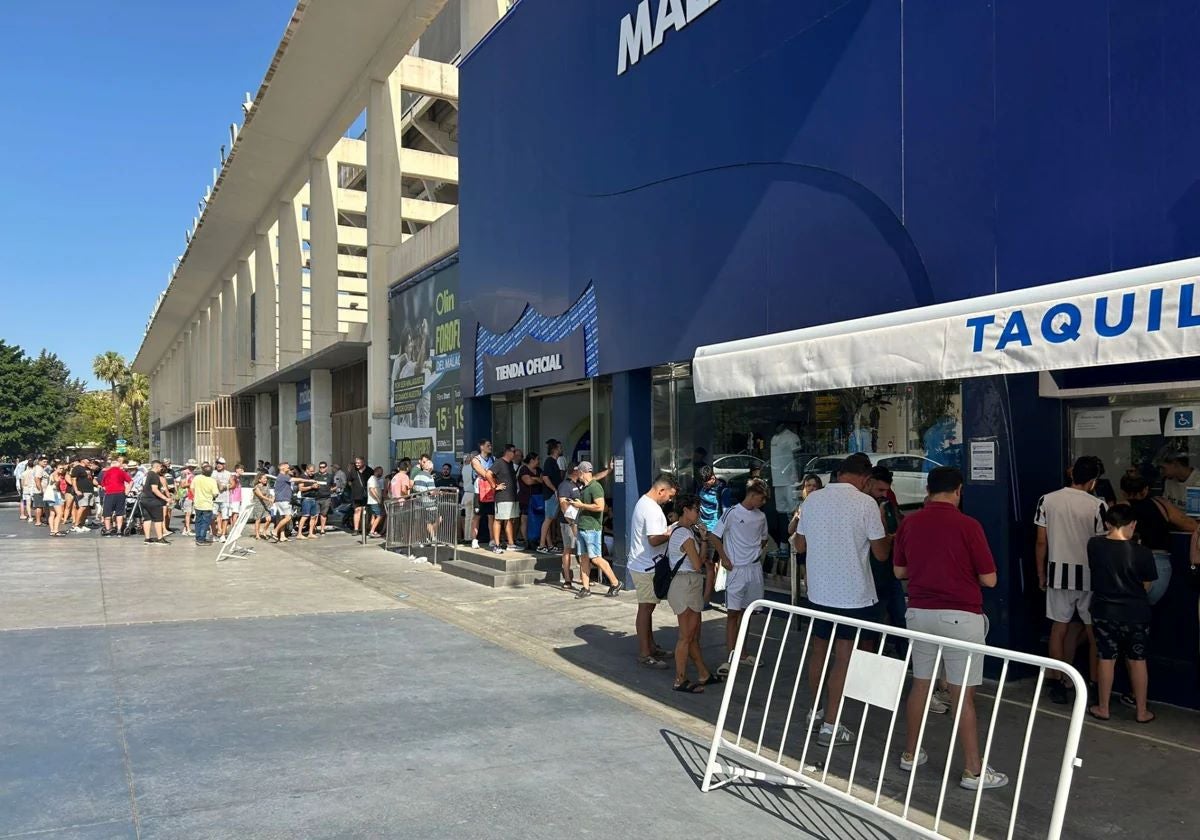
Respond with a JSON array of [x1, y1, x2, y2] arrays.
[[0, 340, 84, 457]]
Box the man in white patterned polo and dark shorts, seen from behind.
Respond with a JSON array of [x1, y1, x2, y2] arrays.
[[792, 455, 892, 746]]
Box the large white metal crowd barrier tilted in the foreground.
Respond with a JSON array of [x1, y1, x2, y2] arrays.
[[702, 600, 1087, 840]]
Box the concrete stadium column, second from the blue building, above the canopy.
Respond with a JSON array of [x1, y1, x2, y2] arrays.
[[308, 157, 340, 353]]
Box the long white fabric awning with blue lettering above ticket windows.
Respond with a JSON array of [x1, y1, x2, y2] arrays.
[[692, 258, 1200, 402]]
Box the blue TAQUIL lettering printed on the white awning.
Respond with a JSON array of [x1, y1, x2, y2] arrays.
[[965, 282, 1200, 353]]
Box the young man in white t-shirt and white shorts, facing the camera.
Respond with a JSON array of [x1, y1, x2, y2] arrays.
[[708, 479, 770, 677]]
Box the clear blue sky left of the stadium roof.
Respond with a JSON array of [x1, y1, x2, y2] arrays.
[[0, 0, 295, 382]]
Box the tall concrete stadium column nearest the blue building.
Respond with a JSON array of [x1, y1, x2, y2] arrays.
[[367, 71, 404, 464]]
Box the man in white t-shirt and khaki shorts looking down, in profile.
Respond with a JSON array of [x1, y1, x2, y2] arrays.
[[625, 473, 678, 671]]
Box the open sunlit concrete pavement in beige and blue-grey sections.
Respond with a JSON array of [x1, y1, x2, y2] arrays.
[[0, 510, 907, 840]]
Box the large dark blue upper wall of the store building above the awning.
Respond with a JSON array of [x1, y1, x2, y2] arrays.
[[461, 0, 1200, 380]]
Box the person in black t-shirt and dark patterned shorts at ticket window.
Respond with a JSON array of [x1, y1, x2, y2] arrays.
[[1087, 504, 1158, 724]]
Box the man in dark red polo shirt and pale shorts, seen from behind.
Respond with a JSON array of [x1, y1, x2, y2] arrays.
[[892, 467, 1008, 791]]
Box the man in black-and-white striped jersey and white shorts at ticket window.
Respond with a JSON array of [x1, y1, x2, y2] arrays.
[[1033, 455, 1106, 703]]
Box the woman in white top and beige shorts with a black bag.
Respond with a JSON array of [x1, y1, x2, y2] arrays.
[[667, 496, 721, 694]]
